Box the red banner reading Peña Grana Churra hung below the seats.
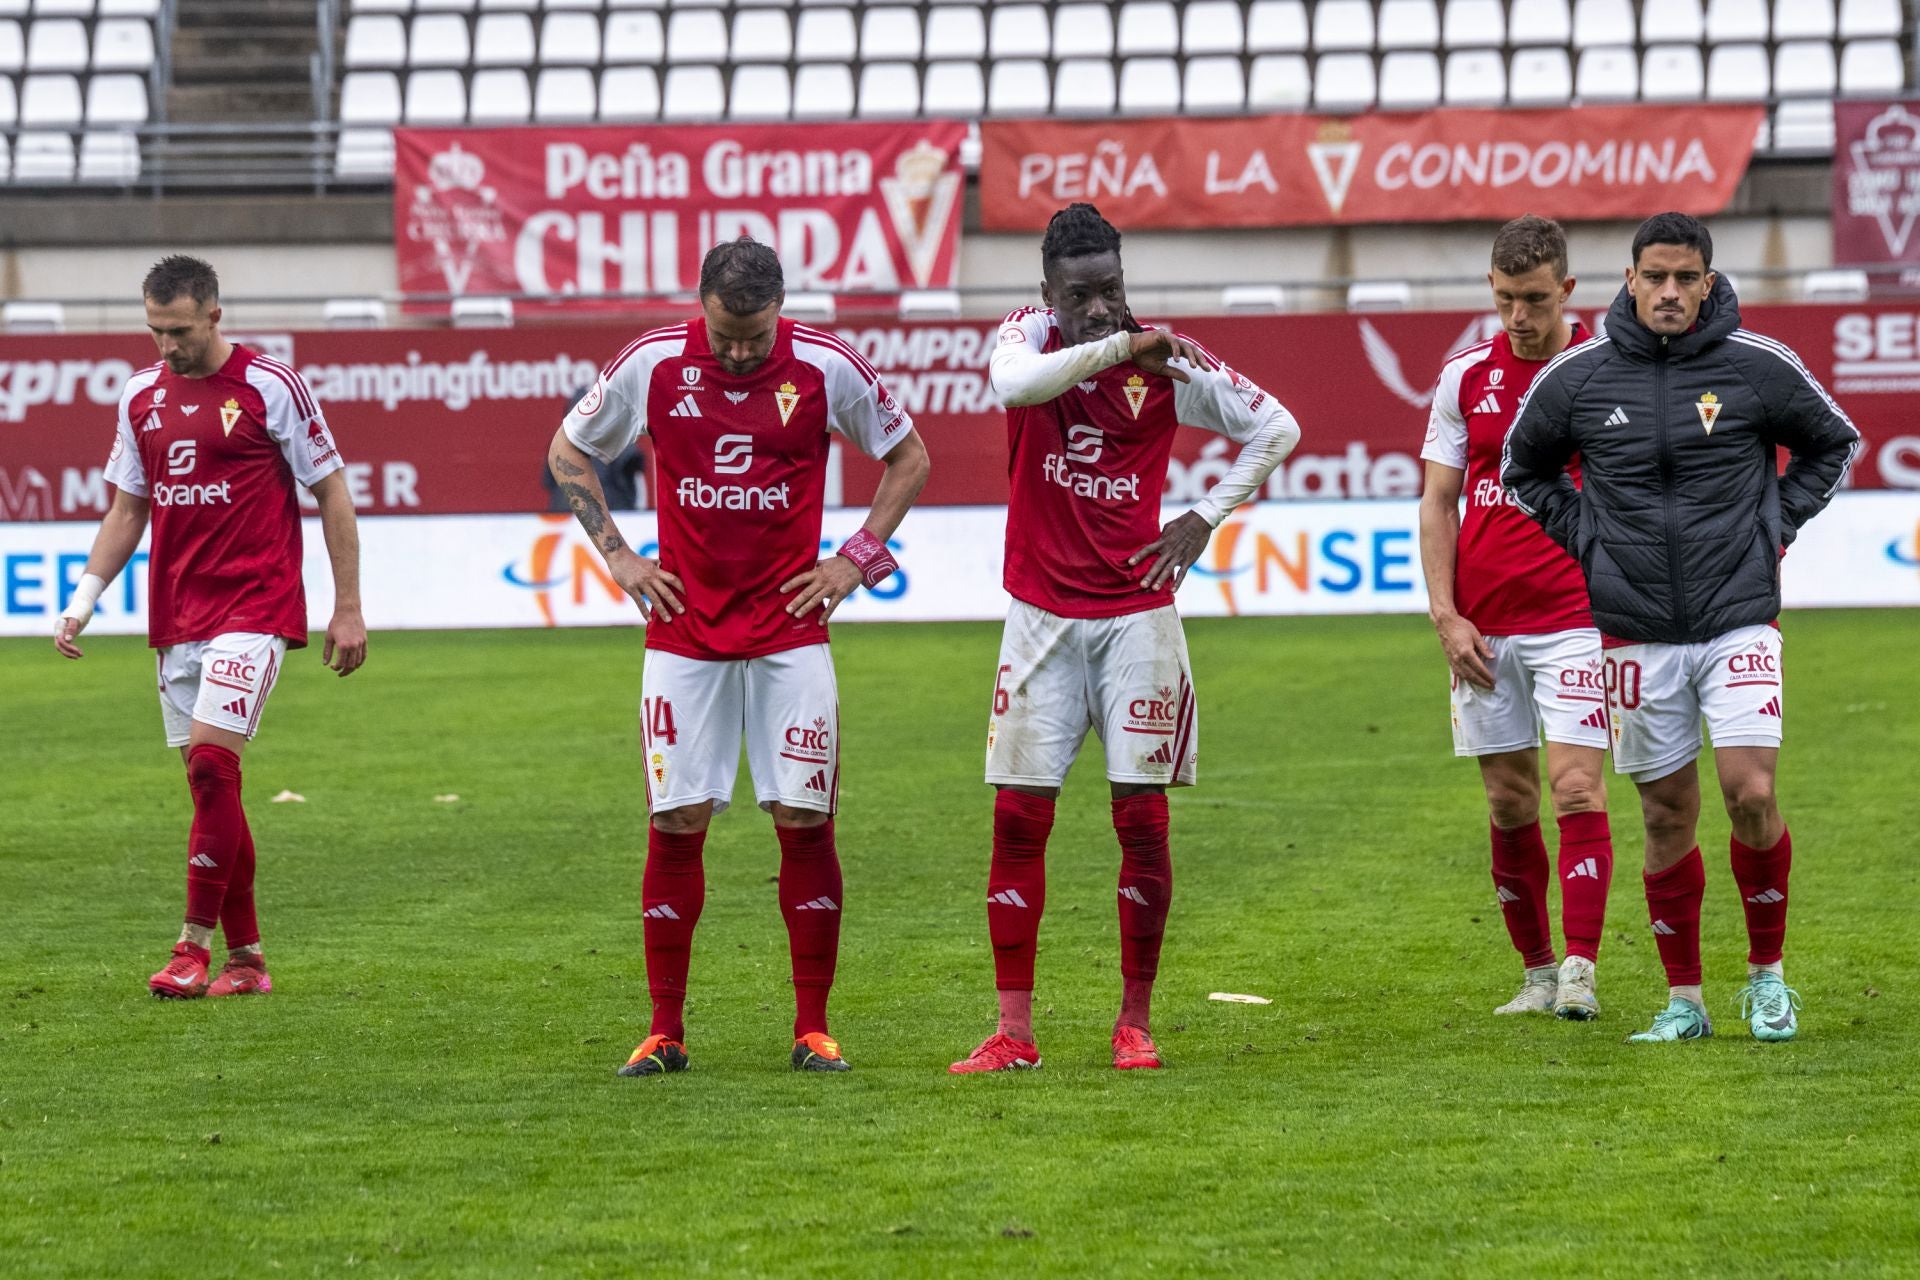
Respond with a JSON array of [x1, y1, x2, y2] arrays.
[[394, 121, 966, 309]]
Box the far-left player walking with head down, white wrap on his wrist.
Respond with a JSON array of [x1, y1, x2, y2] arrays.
[[54, 255, 367, 998]]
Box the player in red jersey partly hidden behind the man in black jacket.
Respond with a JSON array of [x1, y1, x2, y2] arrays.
[[1421, 215, 1613, 1021]]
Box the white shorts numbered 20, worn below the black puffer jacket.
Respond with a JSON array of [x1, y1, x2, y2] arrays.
[[1607, 626, 1786, 783]]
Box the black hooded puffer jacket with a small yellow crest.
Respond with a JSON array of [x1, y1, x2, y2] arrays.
[[1500, 276, 1860, 645]]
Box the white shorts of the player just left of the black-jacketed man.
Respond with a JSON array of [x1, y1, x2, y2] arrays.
[[1453, 628, 1607, 756]]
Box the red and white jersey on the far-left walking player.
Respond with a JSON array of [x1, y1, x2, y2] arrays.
[[106, 344, 344, 649]]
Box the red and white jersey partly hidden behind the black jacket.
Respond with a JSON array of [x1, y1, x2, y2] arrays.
[[1421, 324, 1594, 635]]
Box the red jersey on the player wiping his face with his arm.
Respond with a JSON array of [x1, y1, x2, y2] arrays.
[[998, 307, 1273, 618]]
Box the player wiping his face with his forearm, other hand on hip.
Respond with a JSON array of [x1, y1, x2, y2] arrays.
[[950, 203, 1300, 1075]]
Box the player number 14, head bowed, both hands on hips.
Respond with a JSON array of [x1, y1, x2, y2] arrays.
[[547, 238, 927, 1077]]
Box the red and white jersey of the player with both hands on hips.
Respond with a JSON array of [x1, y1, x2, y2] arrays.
[[564, 317, 914, 660]]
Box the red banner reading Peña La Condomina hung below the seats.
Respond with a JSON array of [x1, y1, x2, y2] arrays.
[[979, 106, 1764, 230]]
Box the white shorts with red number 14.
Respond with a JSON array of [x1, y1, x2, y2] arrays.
[[639, 645, 839, 814]]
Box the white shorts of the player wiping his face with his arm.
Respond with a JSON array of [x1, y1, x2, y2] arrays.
[[987, 601, 1200, 787]]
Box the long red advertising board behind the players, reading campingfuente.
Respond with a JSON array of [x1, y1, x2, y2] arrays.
[[0, 303, 1920, 520]]
